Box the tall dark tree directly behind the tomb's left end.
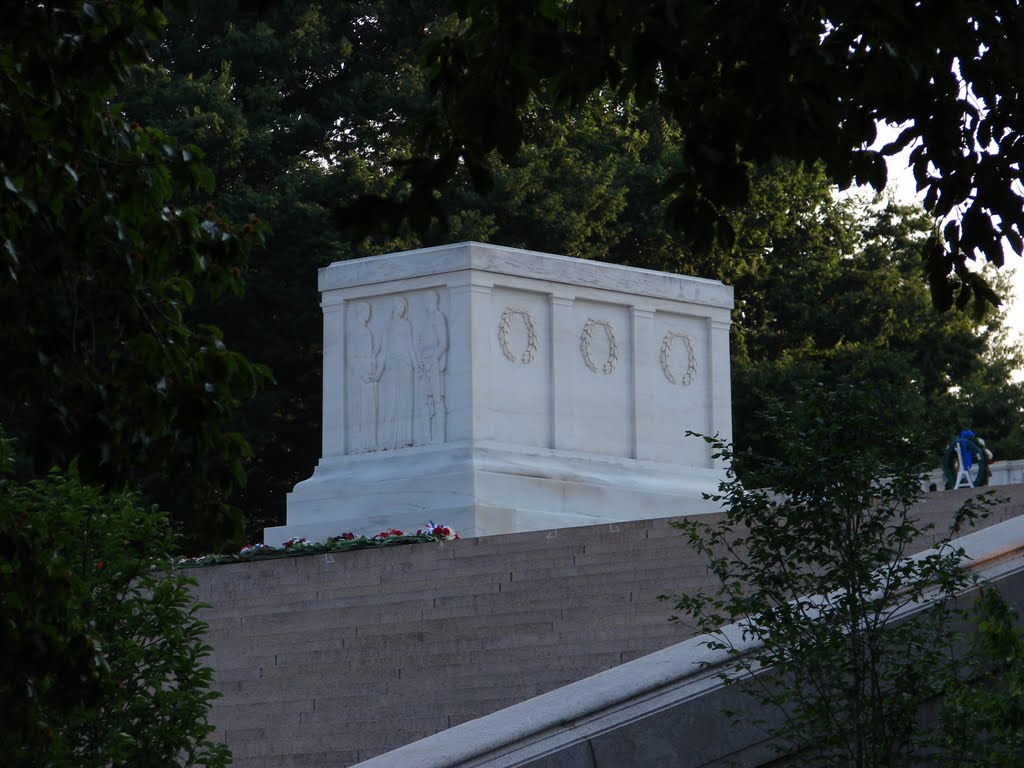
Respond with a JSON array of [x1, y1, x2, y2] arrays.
[[121, 0, 433, 539]]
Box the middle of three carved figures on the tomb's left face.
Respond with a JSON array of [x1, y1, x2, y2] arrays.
[[378, 296, 416, 451]]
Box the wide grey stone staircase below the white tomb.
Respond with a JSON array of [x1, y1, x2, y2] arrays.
[[196, 486, 1024, 768]]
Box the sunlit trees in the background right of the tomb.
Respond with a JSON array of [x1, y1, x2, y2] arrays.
[[719, 164, 1024, 466]]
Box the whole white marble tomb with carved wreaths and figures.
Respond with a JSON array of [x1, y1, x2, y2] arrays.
[[264, 243, 733, 546]]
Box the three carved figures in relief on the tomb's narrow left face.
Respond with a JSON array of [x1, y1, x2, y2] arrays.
[[348, 291, 449, 453]]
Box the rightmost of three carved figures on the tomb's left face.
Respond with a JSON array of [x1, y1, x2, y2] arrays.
[[414, 291, 449, 444]]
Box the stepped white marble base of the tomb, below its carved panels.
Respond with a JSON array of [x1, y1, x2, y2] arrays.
[[264, 438, 724, 546]]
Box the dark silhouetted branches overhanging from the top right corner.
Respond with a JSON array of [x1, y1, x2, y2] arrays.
[[352, 0, 1024, 309]]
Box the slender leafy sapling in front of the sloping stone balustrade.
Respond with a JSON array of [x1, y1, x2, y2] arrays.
[[676, 380, 992, 768]]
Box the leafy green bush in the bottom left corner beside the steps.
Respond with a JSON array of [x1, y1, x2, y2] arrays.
[[0, 434, 229, 768]]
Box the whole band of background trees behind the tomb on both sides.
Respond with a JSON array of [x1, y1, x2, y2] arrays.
[[121, 0, 1024, 539]]
